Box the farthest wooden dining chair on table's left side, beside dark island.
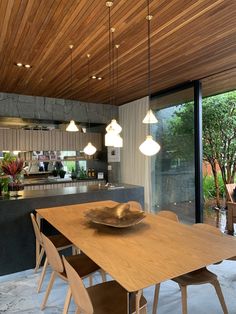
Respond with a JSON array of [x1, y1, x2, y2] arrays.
[[30, 213, 75, 292]]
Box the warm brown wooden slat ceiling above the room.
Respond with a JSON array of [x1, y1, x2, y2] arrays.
[[0, 0, 236, 104]]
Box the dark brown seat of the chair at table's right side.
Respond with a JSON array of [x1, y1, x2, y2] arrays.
[[172, 267, 217, 286]]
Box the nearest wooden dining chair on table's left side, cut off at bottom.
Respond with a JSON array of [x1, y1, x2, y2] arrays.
[[63, 256, 147, 314]]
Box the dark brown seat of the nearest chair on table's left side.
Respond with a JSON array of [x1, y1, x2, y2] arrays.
[[87, 281, 147, 314]]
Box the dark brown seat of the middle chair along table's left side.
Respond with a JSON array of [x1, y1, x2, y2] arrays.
[[61, 252, 100, 278]]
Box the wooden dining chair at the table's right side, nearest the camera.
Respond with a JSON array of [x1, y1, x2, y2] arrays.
[[153, 218, 228, 314]]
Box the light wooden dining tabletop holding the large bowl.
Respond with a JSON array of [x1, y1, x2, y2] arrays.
[[37, 201, 236, 292]]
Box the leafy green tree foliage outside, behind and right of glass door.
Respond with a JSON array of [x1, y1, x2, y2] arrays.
[[165, 91, 236, 183]]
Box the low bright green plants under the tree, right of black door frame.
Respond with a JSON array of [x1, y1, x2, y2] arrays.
[[203, 174, 225, 199]]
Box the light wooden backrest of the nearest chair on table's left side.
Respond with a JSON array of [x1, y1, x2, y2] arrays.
[[62, 256, 94, 314]]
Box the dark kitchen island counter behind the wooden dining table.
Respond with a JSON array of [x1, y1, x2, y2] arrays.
[[0, 184, 144, 275]]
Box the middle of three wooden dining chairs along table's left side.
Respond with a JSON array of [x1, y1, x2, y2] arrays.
[[41, 233, 103, 314]]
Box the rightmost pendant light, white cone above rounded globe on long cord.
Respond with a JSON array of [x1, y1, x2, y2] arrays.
[[139, 0, 161, 156]]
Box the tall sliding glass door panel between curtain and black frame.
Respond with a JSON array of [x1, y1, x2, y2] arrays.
[[151, 87, 195, 223]]
